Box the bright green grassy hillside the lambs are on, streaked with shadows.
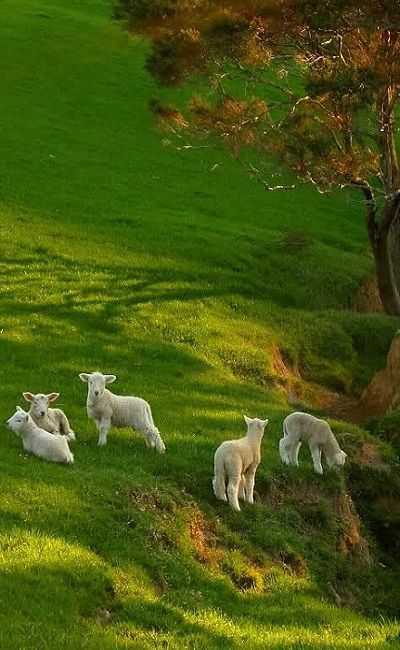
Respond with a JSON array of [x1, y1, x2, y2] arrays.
[[0, 0, 399, 648]]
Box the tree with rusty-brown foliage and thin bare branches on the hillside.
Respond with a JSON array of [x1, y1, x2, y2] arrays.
[[116, 0, 400, 315]]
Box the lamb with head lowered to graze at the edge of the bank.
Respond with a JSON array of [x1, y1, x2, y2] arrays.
[[279, 412, 347, 474]]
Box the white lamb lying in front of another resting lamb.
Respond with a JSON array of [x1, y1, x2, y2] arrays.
[[6, 406, 74, 463]]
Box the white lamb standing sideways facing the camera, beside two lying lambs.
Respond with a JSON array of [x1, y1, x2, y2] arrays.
[[79, 372, 165, 454]]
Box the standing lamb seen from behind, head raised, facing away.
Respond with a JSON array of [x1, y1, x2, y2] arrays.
[[213, 415, 268, 510]]
